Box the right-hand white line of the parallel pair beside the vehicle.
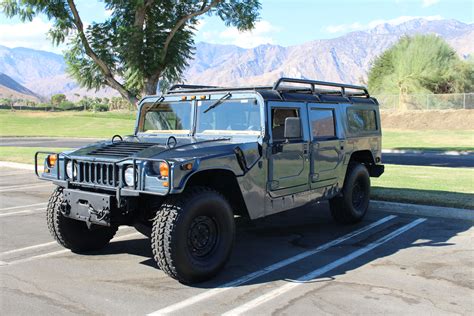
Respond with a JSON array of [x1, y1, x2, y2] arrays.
[[222, 218, 426, 316]]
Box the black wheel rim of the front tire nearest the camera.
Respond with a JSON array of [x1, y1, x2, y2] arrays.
[[188, 216, 218, 259]]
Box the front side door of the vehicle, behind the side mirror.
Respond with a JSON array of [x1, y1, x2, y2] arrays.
[[268, 102, 309, 196]]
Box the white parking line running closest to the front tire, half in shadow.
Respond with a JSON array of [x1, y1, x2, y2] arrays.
[[148, 215, 397, 315]]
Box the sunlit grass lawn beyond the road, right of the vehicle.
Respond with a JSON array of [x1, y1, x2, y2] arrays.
[[382, 129, 474, 151]]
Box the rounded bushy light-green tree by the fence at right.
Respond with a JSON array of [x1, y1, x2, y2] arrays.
[[368, 35, 474, 95]]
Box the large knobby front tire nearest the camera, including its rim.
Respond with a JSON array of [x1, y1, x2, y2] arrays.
[[151, 187, 235, 284]]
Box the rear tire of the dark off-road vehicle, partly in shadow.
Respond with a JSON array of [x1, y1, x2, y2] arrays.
[[329, 163, 370, 224]]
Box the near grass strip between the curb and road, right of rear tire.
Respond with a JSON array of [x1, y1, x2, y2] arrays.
[[371, 165, 474, 209]]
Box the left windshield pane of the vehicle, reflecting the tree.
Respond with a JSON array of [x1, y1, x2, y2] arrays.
[[140, 102, 192, 134]]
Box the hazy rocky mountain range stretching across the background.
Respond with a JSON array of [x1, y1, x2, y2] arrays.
[[0, 18, 474, 100]]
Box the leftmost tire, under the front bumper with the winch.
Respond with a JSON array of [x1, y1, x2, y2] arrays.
[[46, 187, 118, 253]]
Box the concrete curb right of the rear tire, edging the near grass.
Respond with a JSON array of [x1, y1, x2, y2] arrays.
[[369, 201, 474, 221]]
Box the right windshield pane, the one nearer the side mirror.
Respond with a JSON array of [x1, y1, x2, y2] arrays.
[[196, 99, 261, 135]]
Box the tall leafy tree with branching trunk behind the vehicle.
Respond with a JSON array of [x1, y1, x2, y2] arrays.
[[0, 0, 261, 103]]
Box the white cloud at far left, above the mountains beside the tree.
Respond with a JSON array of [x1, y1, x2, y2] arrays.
[[0, 17, 64, 53]]
